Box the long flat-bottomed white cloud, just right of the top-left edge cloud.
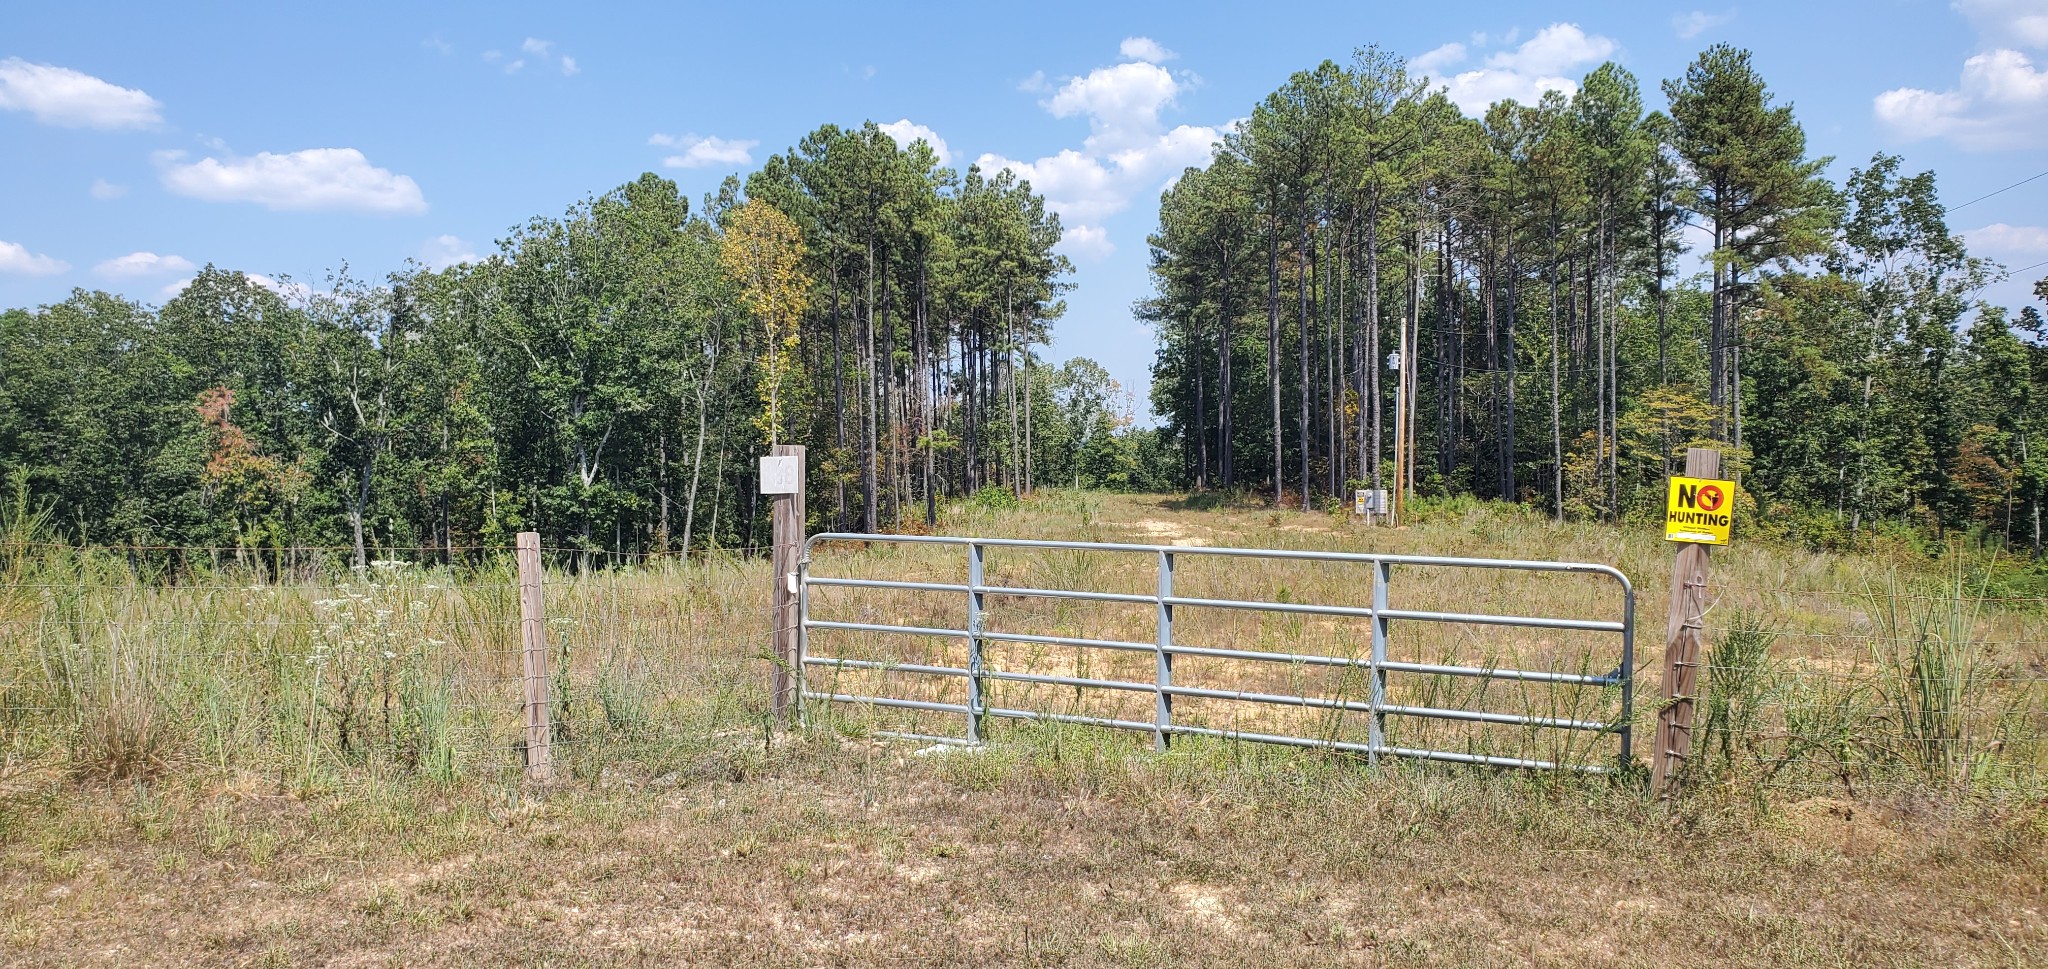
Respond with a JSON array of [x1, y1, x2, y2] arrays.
[[156, 148, 426, 215]]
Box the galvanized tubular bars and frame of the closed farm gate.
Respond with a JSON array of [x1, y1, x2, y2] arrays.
[[797, 533, 1634, 772]]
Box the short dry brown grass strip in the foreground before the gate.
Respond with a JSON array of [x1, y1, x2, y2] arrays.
[[0, 744, 2048, 967]]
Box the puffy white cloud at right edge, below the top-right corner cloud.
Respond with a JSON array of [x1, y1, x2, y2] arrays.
[[1872, 49, 2048, 150]]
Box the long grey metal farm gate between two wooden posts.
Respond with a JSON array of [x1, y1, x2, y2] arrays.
[[795, 533, 1634, 772]]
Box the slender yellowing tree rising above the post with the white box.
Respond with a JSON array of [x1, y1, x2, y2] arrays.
[[719, 199, 811, 445]]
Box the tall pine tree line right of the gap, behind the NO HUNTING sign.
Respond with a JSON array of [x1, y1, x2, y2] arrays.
[[1137, 45, 2048, 553]]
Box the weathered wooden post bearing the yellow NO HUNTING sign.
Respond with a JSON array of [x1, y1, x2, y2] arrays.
[[1651, 447, 1735, 799]]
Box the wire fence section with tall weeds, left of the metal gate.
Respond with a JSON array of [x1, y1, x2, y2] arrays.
[[0, 545, 766, 785]]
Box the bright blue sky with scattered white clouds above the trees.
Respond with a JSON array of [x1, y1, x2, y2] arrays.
[[0, 0, 2048, 410]]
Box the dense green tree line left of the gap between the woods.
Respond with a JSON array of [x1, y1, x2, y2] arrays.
[[0, 123, 1161, 565]]
